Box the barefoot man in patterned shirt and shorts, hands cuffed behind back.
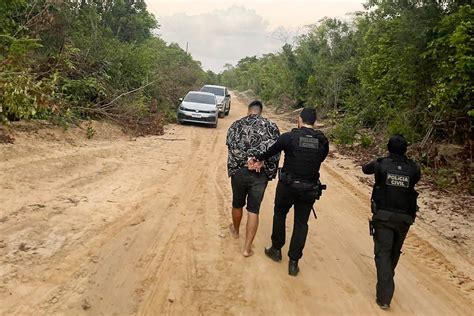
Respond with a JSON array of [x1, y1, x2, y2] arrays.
[[226, 101, 280, 257]]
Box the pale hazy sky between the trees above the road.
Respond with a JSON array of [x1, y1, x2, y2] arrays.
[[146, 0, 366, 72]]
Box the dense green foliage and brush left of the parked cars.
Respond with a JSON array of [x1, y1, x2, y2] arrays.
[[0, 0, 207, 130]]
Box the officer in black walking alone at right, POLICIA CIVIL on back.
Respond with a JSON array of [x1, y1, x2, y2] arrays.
[[362, 135, 421, 309]]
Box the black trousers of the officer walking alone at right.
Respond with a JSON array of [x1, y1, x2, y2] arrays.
[[374, 219, 410, 305]]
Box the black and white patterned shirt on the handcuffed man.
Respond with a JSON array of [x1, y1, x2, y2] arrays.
[[226, 114, 280, 180]]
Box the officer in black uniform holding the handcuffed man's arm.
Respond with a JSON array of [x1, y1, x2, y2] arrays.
[[255, 108, 329, 276]]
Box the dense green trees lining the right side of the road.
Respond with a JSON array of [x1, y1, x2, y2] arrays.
[[220, 0, 474, 143]]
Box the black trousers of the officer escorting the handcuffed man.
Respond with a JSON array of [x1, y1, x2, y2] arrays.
[[272, 181, 316, 260]]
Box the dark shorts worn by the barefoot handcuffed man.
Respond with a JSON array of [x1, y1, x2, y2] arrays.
[[231, 168, 268, 214]]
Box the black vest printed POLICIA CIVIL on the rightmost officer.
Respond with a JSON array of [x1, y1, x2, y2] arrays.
[[372, 157, 418, 216]]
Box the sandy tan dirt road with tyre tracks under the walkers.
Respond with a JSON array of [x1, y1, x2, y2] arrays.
[[0, 99, 474, 315]]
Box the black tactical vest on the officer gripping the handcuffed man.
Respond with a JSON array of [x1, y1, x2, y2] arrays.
[[283, 128, 328, 183]]
